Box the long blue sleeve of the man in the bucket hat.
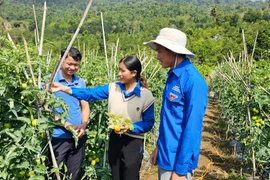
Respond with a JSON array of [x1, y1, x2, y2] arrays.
[[174, 78, 208, 175]]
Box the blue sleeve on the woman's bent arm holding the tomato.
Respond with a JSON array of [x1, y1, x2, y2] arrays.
[[131, 104, 155, 134]]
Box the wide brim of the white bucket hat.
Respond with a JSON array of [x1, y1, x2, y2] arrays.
[[143, 39, 195, 58]]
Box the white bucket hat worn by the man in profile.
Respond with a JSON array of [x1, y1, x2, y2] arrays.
[[143, 28, 194, 58]]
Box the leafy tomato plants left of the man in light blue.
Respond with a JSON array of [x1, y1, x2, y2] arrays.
[[0, 36, 80, 179]]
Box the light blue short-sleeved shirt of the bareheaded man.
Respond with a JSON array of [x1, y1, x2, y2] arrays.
[[52, 70, 86, 138]]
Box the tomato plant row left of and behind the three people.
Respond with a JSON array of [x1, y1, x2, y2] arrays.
[[0, 33, 167, 180]]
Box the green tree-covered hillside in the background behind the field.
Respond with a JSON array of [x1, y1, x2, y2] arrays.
[[0, 0, 270, 69]]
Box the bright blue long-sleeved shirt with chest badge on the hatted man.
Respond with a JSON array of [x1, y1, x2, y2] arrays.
[[157, 59, 208, 174]]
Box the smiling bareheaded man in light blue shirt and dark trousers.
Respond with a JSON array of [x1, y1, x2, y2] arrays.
[[48, 48, 90, 180]]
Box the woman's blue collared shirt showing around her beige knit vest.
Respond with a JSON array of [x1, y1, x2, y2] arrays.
[[72, 82, 154, 134]]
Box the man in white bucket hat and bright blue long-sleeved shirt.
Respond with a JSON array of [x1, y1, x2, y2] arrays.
[[144, 28, 208, 180]]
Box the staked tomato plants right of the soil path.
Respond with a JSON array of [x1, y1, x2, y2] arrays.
[[211, 57, 270, 178]]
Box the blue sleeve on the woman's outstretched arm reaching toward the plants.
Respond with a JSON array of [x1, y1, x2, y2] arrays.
[[72, 84, 109, 102]]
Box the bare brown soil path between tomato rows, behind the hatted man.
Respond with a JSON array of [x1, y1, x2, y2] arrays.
[[141, 98, 243, 180]]
